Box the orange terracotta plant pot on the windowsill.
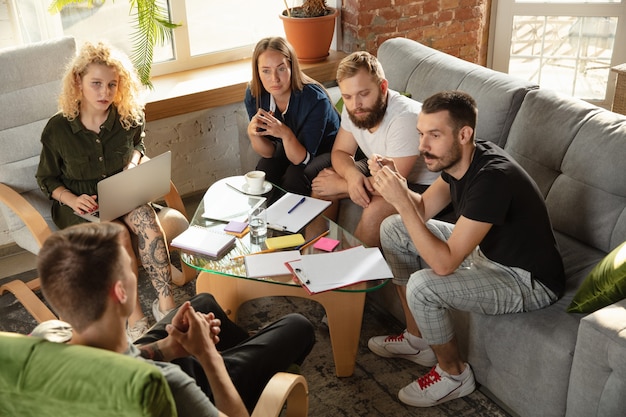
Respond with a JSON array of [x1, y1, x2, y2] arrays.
[[280, 7, 339, 63]]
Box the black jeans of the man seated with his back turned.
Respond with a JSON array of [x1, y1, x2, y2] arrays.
[[135, 293, 315, 412]]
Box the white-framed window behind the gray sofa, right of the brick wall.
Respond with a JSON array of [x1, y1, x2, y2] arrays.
[[490, 0, 626, 107]]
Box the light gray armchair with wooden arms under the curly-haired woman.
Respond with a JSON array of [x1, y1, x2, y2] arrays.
[[0, 37, 196, 322]]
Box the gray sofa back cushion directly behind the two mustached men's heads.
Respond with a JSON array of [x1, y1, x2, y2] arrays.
[[378, 38, 538, 147]]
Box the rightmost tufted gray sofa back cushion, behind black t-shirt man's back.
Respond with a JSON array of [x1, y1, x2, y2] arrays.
[[505, 90, 626, 255]]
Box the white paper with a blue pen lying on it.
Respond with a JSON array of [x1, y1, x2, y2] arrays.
[[267, 193, 330, 233]]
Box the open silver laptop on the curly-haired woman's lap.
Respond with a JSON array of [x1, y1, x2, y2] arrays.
[[75, 151, 172, 222]]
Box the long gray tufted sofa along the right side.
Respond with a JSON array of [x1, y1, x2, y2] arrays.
[[339, 38, 626, 417]]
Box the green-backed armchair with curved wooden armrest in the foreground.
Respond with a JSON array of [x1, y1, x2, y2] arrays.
[[0, 332, 308, 417]]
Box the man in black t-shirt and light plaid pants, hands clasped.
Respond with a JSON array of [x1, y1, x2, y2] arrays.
[[368, 91, 565, 407]]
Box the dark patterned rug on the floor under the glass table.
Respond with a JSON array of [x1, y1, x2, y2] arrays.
[[0, 254, 507, 417]]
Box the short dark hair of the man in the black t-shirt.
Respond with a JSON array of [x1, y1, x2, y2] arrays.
[[422, 90, 478, 137]]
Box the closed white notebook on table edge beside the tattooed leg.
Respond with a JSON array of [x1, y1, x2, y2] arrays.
[[172, 226, 235, 258]]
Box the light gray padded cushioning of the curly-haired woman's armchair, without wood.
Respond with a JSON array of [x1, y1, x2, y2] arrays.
[[0, 37, 76, 253]]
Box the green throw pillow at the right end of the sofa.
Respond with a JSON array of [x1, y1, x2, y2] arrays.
[[567, 242, 626, 313]]
